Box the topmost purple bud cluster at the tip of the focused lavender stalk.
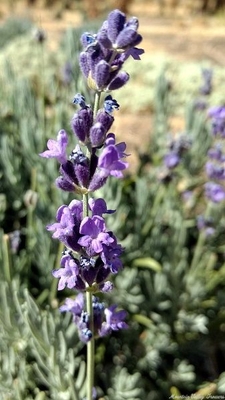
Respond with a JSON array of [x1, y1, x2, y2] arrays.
[[80, 10, 144, 91]]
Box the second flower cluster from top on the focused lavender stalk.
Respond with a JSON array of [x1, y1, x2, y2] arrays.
[[40, 101, 128, 193]]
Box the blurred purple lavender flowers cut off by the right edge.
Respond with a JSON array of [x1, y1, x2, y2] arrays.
[[205, 106, 225, 203]]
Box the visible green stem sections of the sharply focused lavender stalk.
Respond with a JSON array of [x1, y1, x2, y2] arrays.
[[83, 92, 101, 400]]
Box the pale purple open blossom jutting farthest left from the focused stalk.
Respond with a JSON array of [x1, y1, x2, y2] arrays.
[[39, 129, 68, 164]]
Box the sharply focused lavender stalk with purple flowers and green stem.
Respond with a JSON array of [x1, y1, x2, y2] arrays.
[[40, 10, 143, 400]]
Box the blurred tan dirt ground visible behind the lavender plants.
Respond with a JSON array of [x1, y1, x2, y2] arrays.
[[0, 0, 225, 169]]
